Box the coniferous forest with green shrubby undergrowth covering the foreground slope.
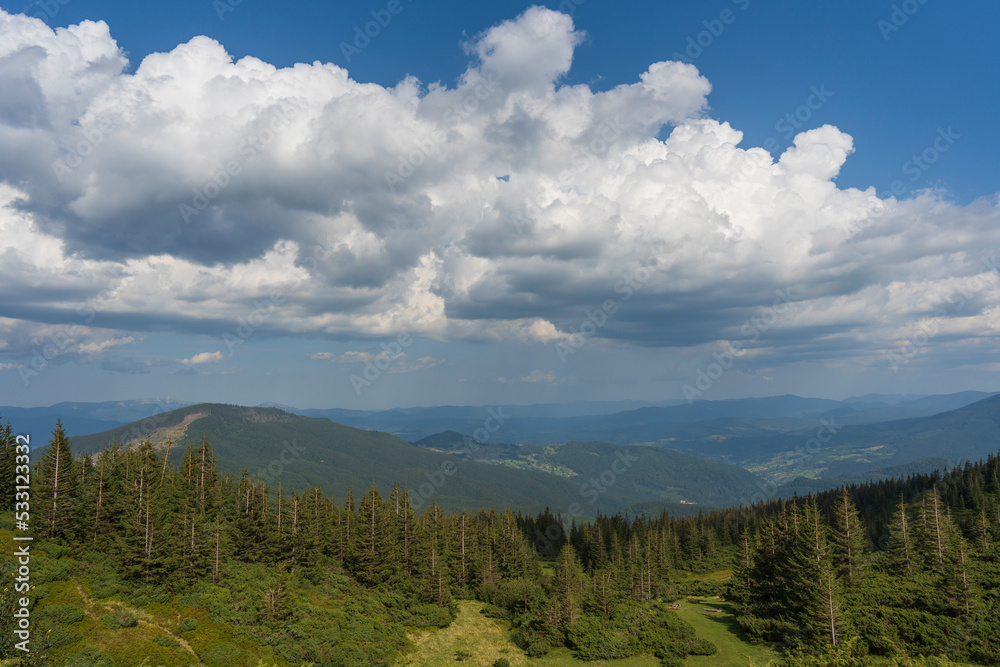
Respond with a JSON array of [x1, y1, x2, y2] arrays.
[[0, 425, 1000, 665]]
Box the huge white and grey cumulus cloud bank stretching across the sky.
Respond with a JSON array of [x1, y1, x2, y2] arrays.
[[0, 7, 1000, 379]]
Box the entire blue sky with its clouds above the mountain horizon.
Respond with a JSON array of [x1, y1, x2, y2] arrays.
[[0, 0, 1000, 409]]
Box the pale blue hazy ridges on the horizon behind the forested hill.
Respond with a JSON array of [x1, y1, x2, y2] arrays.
[[0, 391, 992, 444]]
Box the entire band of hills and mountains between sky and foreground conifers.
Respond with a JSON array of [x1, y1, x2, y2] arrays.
[[9, 391, 1000, 511]]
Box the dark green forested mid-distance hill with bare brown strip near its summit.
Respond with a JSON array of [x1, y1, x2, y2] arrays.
[[64, 404, 760, 517]]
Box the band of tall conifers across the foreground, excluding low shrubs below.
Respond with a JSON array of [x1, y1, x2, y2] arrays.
[[0, 424, 1000, 664]]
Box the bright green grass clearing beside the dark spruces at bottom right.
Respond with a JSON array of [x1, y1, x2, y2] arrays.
[[676, 597, 778, 667]]
